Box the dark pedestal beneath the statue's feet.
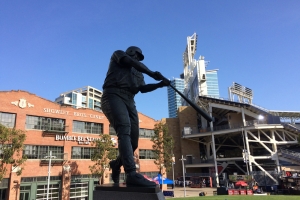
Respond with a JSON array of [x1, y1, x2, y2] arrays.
[[93, 183, 165, 200]]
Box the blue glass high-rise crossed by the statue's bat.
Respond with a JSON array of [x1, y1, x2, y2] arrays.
[[168, 78, 184, 118]]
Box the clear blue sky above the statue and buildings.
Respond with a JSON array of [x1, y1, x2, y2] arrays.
[[0, 0, 300, 120]]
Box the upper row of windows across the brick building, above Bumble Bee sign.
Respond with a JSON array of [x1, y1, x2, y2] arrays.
[[0, 112, 154, 138]]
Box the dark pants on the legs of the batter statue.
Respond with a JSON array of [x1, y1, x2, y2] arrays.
[[101, 90, 139, 173]]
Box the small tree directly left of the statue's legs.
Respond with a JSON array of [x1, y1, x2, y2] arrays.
[[89, 134, 118, 183]]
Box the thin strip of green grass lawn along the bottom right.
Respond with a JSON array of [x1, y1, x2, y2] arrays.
[[172, 195, 300, 200]]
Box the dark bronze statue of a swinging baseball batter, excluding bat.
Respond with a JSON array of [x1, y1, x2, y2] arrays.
[[101, 46, 170, 187]]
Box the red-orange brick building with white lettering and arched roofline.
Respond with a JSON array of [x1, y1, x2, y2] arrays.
[[0, 90, 158, 200]]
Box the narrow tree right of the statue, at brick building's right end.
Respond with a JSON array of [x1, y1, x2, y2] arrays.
[[151, 122, 174, 173]]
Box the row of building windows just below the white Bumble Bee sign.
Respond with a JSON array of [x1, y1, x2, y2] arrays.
[[23, 145, 155, 159]]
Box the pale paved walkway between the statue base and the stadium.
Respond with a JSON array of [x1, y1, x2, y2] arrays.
[[166, 187, 217, 198]]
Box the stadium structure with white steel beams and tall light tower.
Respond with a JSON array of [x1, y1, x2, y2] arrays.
[[164, 34, 300, 190]]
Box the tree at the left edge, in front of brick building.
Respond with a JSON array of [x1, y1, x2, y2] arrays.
[[0, 124, 27, 182]]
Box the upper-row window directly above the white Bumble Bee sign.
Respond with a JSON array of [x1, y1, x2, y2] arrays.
[[73, 121, 103, 134]]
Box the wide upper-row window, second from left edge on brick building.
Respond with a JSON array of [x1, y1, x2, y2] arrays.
[[26, 116, 65, 131]]
